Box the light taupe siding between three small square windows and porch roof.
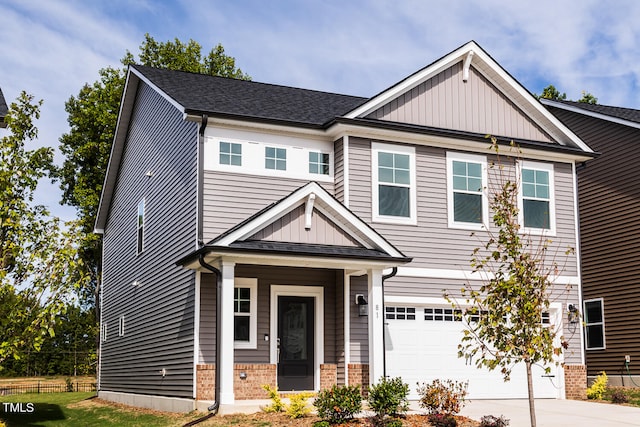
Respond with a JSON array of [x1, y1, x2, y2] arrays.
[[203, 170, 334, 242]]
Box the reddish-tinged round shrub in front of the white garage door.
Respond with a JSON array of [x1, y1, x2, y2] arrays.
[[418, 380, 468, 415]]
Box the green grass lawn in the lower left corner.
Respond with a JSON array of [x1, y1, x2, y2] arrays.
[[0, 393, 195, 427]]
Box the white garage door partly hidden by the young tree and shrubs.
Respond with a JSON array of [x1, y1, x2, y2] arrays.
[[385, 305, 562, 399]]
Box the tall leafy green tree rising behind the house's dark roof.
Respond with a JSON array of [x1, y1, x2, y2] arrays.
[[53, 34, 250, 312]]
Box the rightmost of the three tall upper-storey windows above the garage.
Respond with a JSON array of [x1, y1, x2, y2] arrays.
[[520, 162, 555, 232]]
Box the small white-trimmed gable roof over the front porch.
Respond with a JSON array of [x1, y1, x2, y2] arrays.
[[177, 182, 411, 266]]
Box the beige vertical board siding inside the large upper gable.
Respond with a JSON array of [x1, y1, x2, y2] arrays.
[[368, 62, 552, 142]]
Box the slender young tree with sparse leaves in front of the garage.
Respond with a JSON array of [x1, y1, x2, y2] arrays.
[[446, 138, 571, 427]]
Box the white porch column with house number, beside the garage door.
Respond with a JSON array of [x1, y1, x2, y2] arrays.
[[367, 270, 384, 384]]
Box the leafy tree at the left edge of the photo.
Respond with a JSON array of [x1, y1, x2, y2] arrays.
[[0, 92, 86, 363]]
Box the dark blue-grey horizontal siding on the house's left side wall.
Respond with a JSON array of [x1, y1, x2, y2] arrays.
[[100, 83, 197, 398]]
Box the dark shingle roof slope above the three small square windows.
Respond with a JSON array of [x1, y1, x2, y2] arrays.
[[133, 65, 367, 127]]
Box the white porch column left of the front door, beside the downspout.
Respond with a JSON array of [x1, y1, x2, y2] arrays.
[[216, 261, 236, 405]]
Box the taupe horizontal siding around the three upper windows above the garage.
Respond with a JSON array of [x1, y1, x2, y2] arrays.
[[349, 137, 577, 276]]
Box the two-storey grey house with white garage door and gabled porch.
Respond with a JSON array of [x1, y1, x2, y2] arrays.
[[96, 42, 593, 410]]
